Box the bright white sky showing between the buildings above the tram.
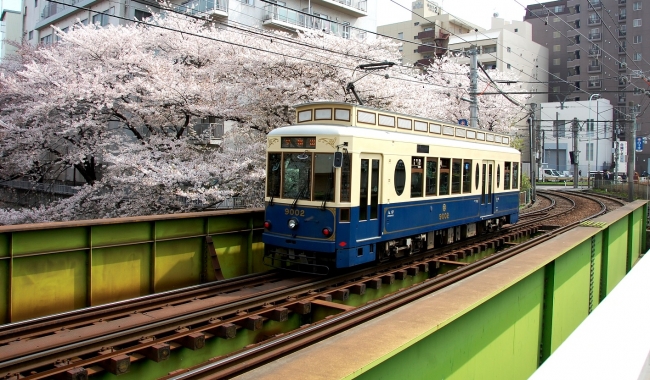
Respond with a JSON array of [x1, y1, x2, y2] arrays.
[[377, 0, 528, 29]]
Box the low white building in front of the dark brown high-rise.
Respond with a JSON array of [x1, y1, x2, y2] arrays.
[[538, 99, 616, 176]]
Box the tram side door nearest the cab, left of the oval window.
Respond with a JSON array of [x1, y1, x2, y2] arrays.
[[357, 154, 381, 240]]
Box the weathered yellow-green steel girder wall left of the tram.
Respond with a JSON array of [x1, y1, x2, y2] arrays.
[[0, 209, 266, 323]]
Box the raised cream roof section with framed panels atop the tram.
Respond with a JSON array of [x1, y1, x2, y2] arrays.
[[294, 101, 510, 146]]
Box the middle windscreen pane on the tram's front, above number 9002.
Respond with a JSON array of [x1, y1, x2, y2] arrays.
[[282, 153, 312, 199]]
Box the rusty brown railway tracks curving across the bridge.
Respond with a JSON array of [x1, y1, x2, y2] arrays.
[[0, 192, 615, 379]]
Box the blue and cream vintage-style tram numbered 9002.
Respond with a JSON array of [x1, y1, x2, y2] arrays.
[[263, 102, 520, 273]]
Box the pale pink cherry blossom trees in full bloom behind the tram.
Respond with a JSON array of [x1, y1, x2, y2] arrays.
[[0, 13, 521, 224]]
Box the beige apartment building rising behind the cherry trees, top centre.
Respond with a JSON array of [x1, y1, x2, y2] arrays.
[[377, 0, 484, 65]]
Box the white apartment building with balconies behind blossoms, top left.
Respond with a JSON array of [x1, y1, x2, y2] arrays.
[[23, 0, 377, 44]]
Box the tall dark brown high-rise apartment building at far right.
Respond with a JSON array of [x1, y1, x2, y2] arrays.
[[525, 0, 650, 172]]
